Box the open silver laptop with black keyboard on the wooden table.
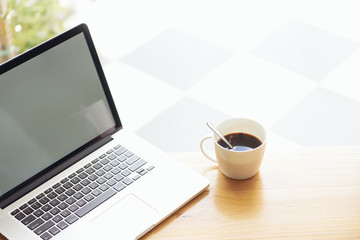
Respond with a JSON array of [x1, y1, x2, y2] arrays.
[[0, 24, 209, 240]]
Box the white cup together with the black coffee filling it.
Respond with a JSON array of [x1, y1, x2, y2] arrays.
[[200, 118, 267, 180]]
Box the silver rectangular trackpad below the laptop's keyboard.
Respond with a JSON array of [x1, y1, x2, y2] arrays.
[[91, 194, 158, 239]]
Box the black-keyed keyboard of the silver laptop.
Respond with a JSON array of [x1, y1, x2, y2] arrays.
[[11, 145, 154, 239]]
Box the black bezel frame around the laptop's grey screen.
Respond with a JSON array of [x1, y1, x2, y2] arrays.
[[0, 23, 122, 209]]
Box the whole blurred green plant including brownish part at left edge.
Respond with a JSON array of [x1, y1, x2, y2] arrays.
[[0, 0, 70, 61]]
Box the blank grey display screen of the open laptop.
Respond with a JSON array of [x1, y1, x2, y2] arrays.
[[0, 24, 119, 204]]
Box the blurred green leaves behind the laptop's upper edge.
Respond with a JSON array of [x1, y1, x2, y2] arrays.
[[8, 0, 70, 54]]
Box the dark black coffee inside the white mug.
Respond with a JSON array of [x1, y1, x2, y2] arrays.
[[218, 133, 262, 151]]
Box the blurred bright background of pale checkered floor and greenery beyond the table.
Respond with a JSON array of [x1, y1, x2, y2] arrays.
[[0, 0, 360, 152]]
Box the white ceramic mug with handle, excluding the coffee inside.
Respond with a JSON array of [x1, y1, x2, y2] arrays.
[[200, 118, 266, 179]]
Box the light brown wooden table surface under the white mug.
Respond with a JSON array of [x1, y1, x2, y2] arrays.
[[0, 147, 360, 240]]
